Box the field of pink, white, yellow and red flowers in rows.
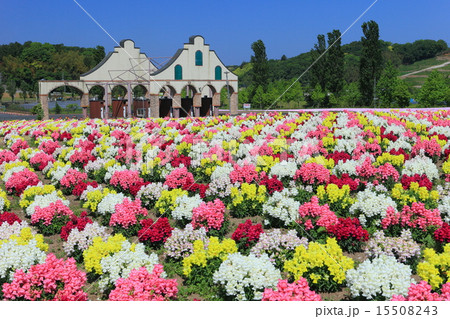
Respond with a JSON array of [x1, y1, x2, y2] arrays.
[[0, 110, 450, 301]]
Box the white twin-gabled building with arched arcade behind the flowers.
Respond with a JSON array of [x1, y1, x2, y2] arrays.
[[39, 35, 238, 118]]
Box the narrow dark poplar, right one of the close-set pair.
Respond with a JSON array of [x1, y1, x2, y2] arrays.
[[326, 30, 344, 94]]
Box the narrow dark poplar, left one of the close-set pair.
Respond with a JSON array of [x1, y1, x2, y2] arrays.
[[310, 34, 328, 91]]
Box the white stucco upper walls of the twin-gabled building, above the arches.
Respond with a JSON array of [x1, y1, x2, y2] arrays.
[[39, 36, 238, 95]]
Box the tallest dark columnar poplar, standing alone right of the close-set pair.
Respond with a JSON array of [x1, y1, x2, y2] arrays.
[[359, 20, 383, 106]]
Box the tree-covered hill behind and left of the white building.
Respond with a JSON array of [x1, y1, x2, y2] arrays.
[[0, 41, 105, 100]]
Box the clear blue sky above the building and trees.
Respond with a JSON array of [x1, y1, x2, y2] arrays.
[[0, 0, 450, 65]]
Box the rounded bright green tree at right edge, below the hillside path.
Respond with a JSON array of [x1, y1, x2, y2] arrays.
[[418, 70, 449, 107]]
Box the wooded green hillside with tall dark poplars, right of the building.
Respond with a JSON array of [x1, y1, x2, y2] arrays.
[[233, 21, 450, 107]]
